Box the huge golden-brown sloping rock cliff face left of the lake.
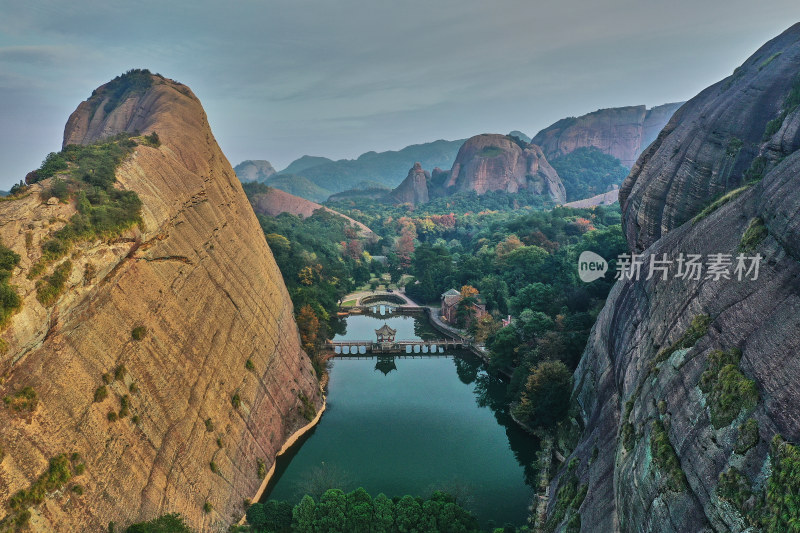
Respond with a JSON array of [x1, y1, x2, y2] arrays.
[[0, 72, 321, 531]]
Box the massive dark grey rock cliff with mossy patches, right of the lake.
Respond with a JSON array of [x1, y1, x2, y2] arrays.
[[548, 25, 800, 532]]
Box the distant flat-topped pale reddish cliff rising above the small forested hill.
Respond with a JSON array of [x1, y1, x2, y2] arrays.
[[531, 103, 682, 167]]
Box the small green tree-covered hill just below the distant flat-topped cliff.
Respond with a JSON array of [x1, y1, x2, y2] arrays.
[[548, 146, 630, 202]]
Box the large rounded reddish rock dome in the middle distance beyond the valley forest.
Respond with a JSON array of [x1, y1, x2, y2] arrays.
[[446, 134, 566, 203]]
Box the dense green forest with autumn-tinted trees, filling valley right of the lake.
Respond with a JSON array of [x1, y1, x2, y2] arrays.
[[318, 194, 626, 427]]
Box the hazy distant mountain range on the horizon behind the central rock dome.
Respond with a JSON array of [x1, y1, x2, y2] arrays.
[[235, 103, 682, 202]]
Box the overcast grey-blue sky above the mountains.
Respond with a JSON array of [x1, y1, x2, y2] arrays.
[[0, 0, 800, 189]]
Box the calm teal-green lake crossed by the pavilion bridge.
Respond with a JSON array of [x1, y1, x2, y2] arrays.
[[264, 315, 538, 525]]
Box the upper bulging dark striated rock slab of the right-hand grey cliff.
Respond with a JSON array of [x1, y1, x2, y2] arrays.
[[620, 28, 800, 254]]
